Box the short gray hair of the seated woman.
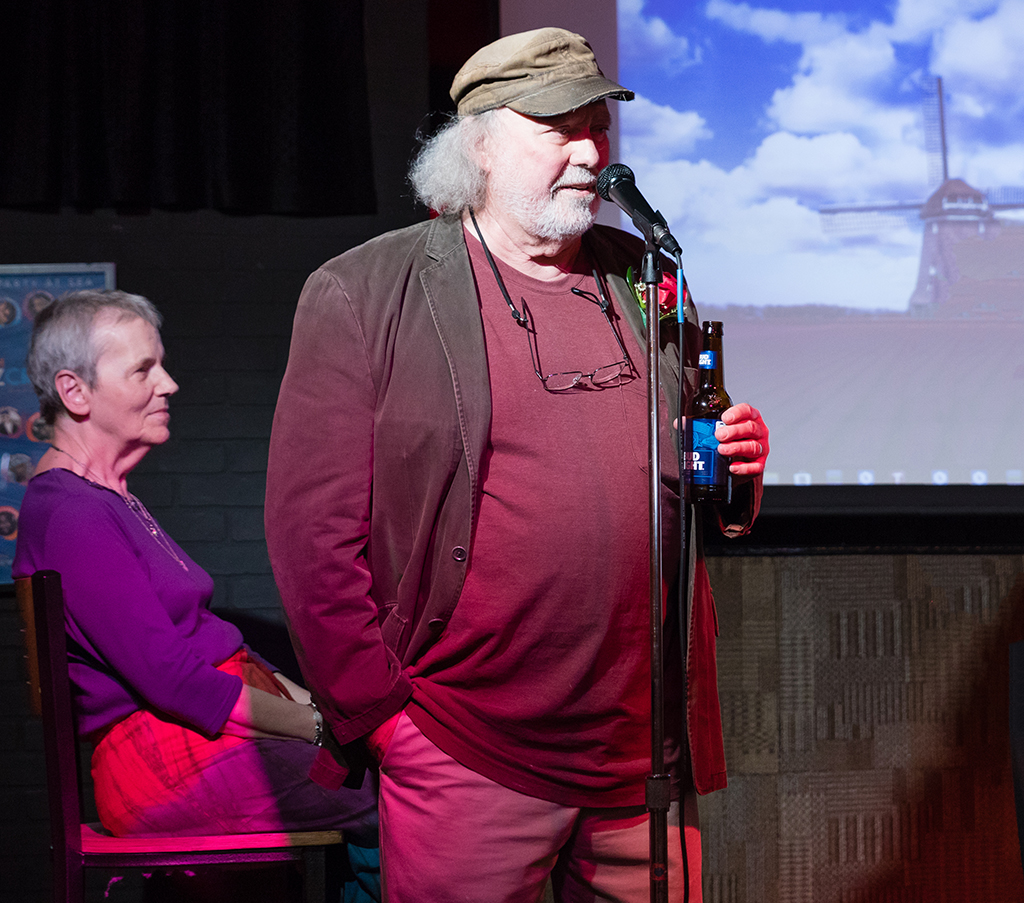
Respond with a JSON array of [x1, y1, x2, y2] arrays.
[[28, 290, 163, 425]]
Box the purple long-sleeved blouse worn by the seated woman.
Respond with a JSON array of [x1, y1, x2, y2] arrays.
[[12, 469, 242, 736]]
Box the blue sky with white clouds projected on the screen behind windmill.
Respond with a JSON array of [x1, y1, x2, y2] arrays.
[[616, 0, 1024, 309]]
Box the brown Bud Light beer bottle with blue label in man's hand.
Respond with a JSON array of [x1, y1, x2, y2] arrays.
[[684, 319, 732, 503]]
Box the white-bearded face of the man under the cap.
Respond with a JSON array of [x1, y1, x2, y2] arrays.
[[483, 100, 611, 241]]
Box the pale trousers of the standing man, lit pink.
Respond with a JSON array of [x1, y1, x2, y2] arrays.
[[380, 714, 700, 903]]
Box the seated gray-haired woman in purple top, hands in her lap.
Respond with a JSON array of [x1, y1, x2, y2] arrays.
[[13, 291, 377, 892]]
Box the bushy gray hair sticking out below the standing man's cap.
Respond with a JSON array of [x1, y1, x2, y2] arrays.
[[409, 110, 499, 216]]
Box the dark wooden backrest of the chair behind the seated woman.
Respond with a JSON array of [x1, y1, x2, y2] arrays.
[[15, 570, 82, 858]]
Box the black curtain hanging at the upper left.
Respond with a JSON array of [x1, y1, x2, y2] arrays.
[[0, 0, 376, 216]]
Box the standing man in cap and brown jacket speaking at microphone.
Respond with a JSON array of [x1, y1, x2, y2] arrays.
[[266, 29, 768, 903]]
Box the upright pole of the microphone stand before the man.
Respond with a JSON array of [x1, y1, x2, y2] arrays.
[[641, 239, 682, 903]]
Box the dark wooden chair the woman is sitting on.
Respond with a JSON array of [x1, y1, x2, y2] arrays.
[[15, 570, 343, 903]]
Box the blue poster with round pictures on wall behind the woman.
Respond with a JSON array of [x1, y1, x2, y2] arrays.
[[0, 263, 115, 584]]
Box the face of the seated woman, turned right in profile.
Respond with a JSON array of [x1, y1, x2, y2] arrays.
[[89, 316, 178, 450]]
